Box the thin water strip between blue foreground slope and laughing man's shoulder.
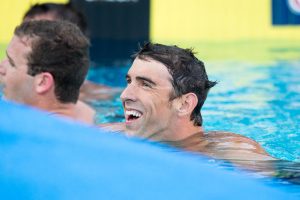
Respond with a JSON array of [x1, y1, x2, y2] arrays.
[[162, 141, 300, 194]]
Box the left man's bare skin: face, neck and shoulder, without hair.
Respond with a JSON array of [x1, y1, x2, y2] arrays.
[[0, 36, 95, 124]]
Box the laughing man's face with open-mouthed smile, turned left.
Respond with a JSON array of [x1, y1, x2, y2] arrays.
[[121, 58, 176, 139]]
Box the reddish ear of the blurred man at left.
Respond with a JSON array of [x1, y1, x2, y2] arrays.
[[34, 72, 55, 94]]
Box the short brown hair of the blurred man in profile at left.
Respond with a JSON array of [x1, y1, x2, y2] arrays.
[[14, 20, 89, 103]]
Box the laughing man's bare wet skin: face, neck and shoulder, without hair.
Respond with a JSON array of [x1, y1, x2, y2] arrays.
[[106, 58, 274, 164]]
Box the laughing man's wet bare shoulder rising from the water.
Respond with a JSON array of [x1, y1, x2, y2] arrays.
[[205, 131, 274, 160]]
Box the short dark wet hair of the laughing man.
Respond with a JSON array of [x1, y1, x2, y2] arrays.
[[133, 42, 217, 126]]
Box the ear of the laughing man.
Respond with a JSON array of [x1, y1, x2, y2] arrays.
[[177, 93, 198, 116]]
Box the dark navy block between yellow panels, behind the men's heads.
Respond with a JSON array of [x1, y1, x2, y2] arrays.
[[71, 0, 150, 65]]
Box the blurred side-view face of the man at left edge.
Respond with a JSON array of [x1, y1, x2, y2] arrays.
[[0, 36, 34, 104]]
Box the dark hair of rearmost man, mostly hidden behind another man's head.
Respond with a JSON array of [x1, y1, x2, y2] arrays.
[[23, 3, 88, 35]]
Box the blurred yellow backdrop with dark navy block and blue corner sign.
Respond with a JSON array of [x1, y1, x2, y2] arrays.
[[0, 0, 300, 65]]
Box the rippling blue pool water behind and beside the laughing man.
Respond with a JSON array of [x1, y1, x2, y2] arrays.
[[89, 61, 300, 162]]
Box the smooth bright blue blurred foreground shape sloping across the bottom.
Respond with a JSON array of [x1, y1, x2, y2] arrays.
[[0, 100, 296, 200]]
